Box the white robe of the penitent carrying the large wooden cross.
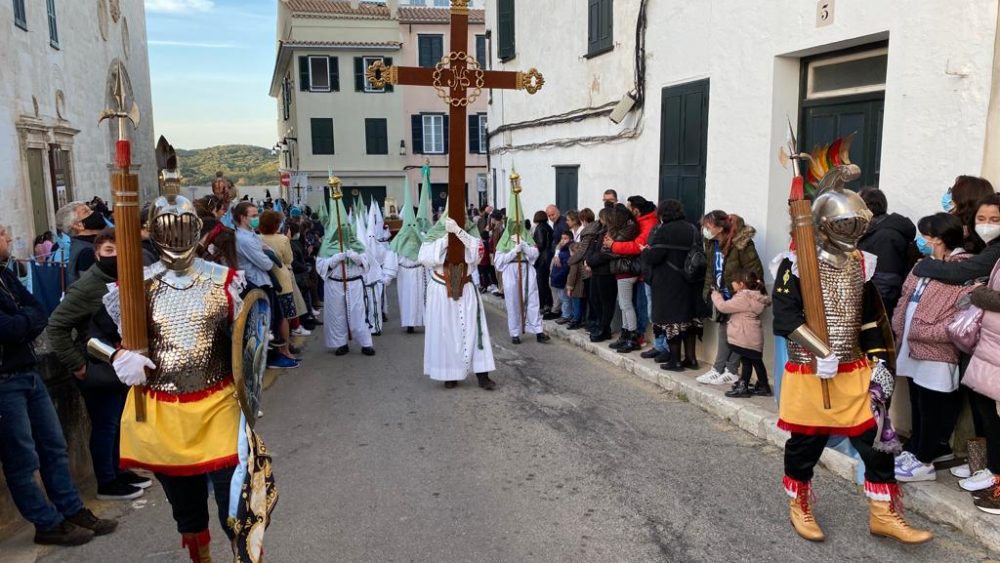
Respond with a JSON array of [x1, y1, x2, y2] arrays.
[[420, 231, 496, 381]]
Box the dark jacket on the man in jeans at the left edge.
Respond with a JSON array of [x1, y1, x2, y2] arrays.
[[0, 267, 48, 373]]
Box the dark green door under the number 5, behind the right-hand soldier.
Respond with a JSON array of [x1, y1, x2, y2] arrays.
[[800, 99, 885, 190]]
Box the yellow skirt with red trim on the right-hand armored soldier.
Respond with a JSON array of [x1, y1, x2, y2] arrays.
[[778, 360, 875, 436]]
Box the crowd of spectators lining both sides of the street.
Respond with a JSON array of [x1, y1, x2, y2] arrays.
[[0, 172, 1000, 545]]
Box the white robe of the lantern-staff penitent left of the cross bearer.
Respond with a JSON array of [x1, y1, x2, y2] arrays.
[[316, 252, 372, 349]]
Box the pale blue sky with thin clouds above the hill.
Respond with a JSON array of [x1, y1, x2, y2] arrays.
[[145, 0, 277, 149]]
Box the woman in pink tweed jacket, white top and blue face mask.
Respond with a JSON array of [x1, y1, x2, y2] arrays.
[[892, 213, 971, 482]]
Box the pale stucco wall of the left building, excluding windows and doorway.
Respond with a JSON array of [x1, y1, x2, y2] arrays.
[[0, 0, 157, 254]]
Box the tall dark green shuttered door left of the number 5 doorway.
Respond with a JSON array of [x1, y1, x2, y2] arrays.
[[660, 80, 708, 220]]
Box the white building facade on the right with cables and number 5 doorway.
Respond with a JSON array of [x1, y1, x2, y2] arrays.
[[486, 0, 1000, 264]]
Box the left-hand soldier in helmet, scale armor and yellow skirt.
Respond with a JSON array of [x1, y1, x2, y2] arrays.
[[89, 195, 277, 562]]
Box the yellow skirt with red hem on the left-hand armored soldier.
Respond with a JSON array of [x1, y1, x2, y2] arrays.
[[121, 379, 240, 476]]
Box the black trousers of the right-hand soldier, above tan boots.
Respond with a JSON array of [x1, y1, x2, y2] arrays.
[[785, 428, 896, 483]]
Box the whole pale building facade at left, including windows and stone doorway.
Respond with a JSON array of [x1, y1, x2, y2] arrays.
[[0, 0, 158, 258]]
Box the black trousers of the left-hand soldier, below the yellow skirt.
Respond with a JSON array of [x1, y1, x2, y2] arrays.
[[155, 467, 235, 539]]
